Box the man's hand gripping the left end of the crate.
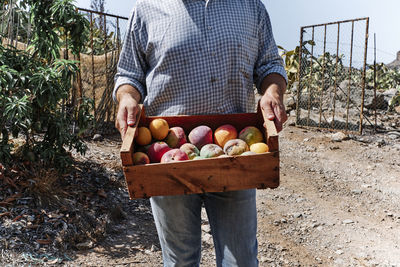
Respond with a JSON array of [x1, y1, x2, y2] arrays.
[[115, 85, 140, 140]]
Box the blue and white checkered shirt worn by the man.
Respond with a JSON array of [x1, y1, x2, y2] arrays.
[[114, 0, 286, 116]]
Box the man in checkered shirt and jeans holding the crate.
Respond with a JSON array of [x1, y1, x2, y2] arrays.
[[114, 0, 287, 267]]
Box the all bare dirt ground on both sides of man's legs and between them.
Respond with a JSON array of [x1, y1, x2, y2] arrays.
[[0, 116, 400, 267]]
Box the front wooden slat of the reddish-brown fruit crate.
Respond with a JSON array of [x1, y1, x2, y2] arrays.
[[124, 152, 279, 198]]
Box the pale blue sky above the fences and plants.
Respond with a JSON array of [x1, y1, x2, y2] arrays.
[[76, 0, 400, 63]]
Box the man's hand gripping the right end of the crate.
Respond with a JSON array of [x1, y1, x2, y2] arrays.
[[260, 74, 287, 132]]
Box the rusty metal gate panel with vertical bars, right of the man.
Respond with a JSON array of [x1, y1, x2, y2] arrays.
[[296, 18, 373, 133]]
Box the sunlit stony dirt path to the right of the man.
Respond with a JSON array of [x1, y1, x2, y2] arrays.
[[258, 128, 400, 266]]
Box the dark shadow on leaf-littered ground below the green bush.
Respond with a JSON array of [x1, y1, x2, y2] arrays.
[[0, 140, 159, 265]]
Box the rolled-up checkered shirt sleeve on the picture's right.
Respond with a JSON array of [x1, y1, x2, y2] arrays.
[[254, 3, 287, 91]]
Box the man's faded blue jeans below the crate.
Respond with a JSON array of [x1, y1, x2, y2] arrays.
[[150, 189, 258, 267]]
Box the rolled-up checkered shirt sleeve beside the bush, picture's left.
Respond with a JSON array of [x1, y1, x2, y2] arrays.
[[113, 10, 147, 102]]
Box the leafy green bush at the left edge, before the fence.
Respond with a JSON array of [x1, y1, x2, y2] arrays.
[[0, 0, 93, 169]]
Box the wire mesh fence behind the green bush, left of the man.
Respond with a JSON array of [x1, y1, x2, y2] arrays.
[[0, 3, 128, 133]]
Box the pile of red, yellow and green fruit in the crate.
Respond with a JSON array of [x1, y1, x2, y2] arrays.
[[133, 118, 269, 165]]
